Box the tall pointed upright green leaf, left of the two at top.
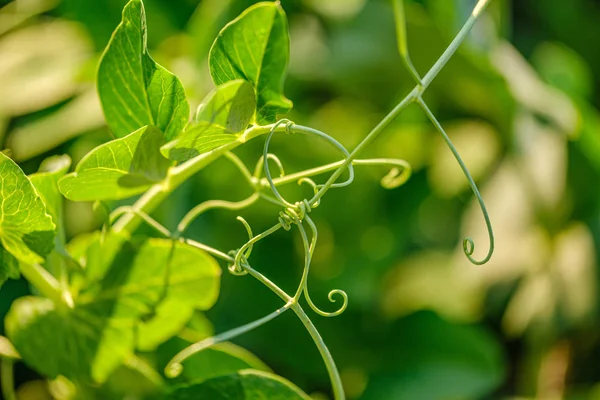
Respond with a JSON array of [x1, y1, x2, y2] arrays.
[[98, 0, 190, 140]]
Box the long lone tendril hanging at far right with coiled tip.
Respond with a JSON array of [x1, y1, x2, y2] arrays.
[[417, 98, 494, 265]]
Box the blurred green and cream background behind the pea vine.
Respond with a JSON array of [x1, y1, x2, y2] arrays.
[[0, 0, 600, 400]]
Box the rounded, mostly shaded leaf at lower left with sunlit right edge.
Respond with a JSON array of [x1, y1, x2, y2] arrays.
[[5, 297, 133, 383]]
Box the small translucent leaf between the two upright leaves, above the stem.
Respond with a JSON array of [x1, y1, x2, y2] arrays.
[[161, 79, 256, 161]]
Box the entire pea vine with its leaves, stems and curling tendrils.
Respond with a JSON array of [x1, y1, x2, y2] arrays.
[[0, 0, 494, 400]]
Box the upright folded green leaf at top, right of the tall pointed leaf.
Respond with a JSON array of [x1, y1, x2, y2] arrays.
[[209, 2, 292, 124]]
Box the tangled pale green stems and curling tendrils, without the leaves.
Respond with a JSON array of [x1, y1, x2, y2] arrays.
[[122, 0, 494, 400]]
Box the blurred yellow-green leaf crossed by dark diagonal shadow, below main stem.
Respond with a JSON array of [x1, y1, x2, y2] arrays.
[[80, 239, 221, 316]]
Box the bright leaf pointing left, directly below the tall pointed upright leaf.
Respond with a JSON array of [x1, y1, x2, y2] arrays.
[[58, 126, 170, 201]]
